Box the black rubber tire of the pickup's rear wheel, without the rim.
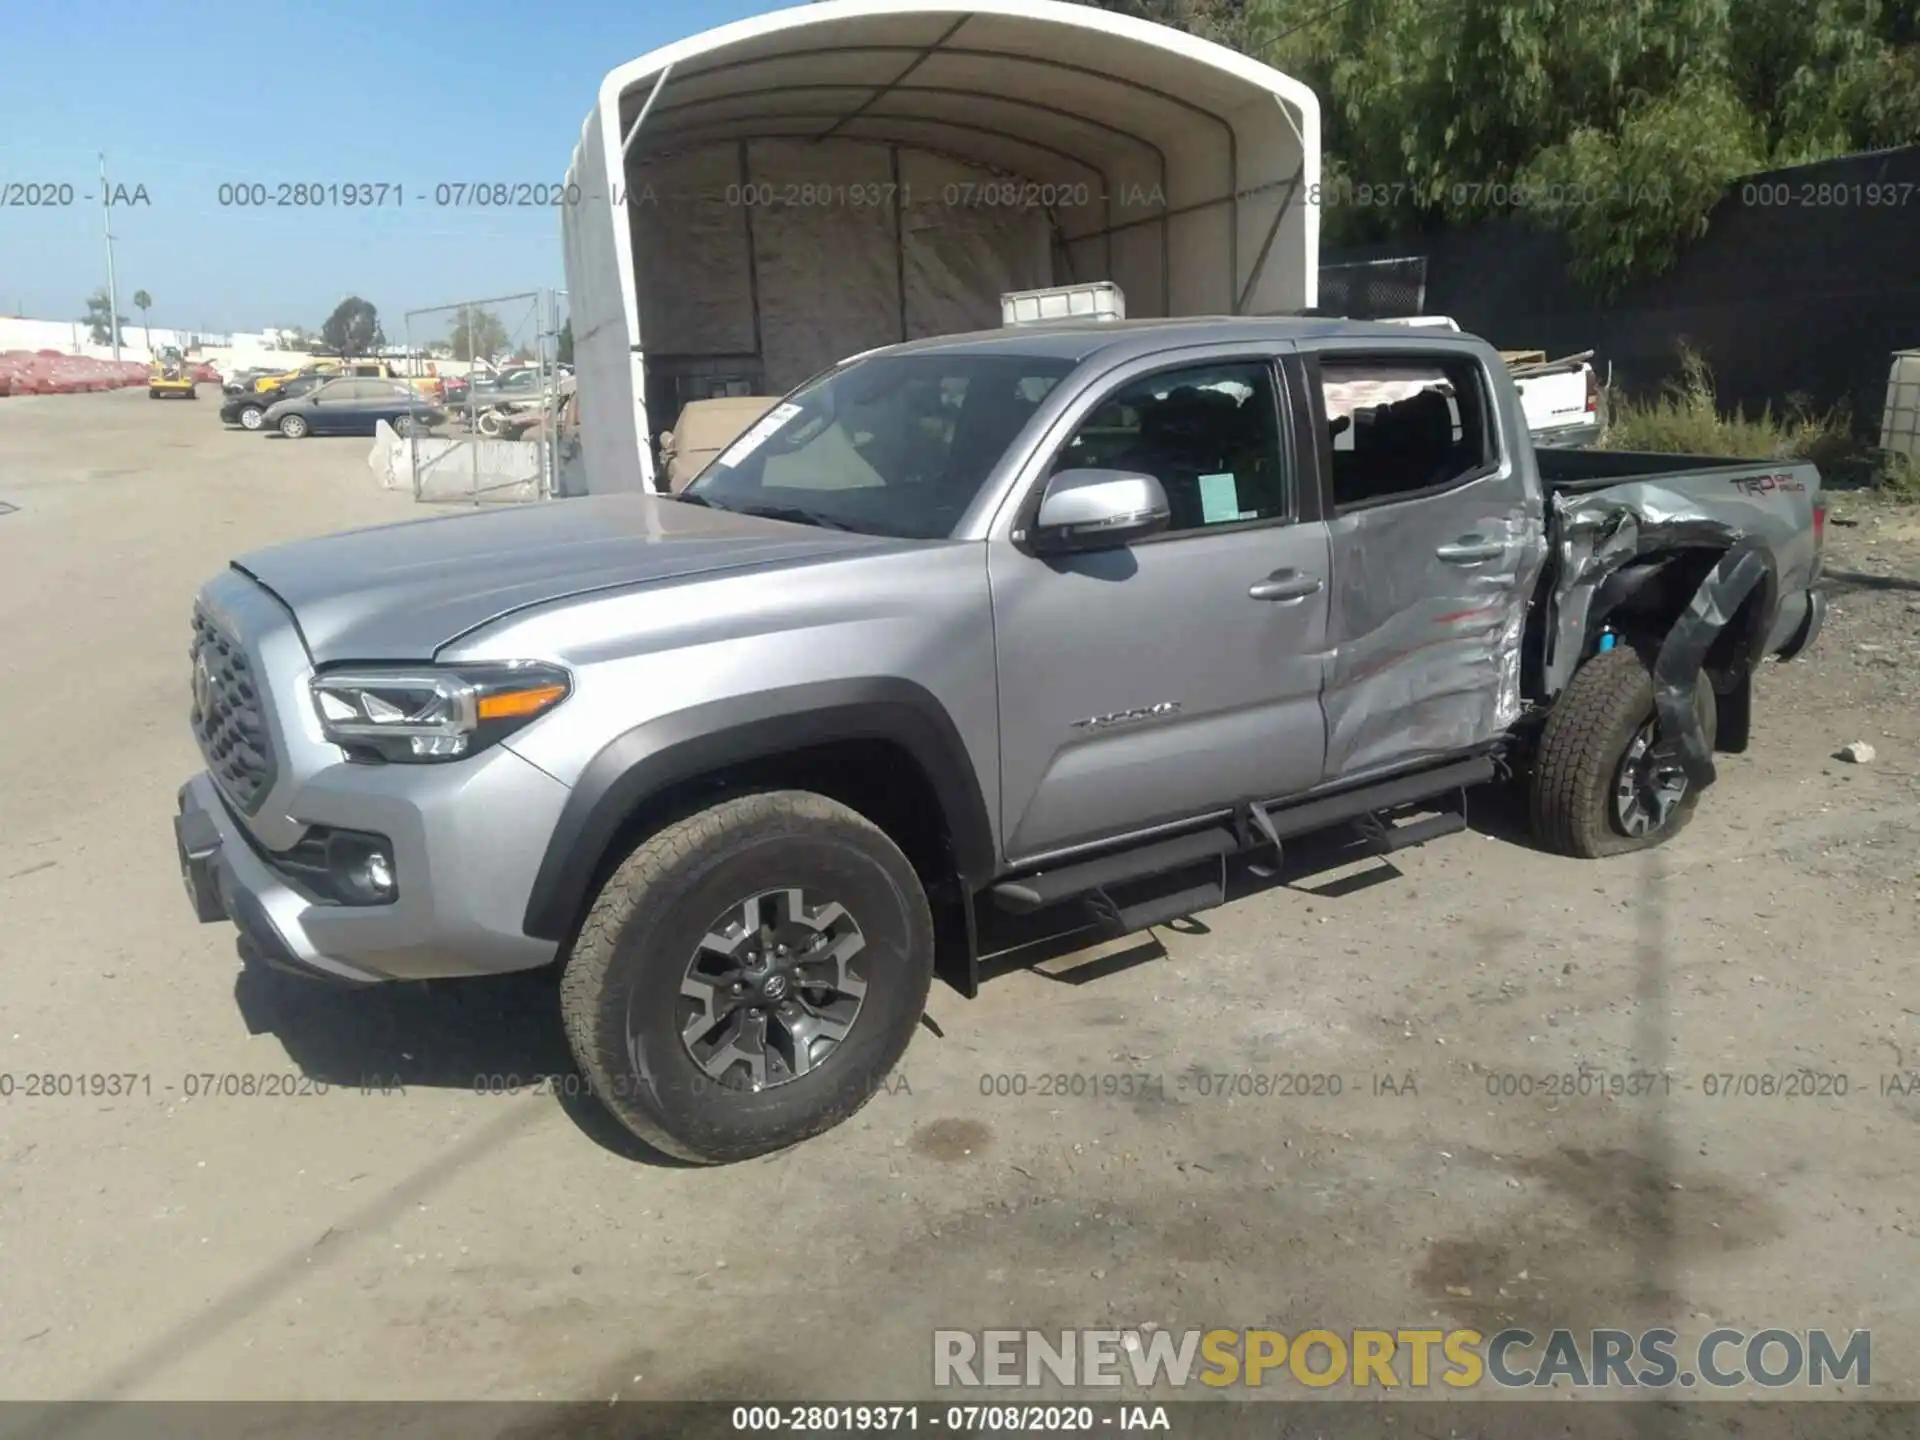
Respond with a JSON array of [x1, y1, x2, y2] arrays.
[[1528, 645, 1716, 860]]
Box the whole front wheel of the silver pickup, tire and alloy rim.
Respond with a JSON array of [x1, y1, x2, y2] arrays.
[[561, 791, 933, 1164]]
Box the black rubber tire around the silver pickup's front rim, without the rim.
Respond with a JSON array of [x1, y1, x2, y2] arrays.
[[561, 791, 933, 1164]]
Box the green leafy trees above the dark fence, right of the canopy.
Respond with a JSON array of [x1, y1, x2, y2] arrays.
[[1092, 0, 1920, 292]]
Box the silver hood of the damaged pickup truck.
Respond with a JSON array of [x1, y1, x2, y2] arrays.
[[232, 495, 899, 664]]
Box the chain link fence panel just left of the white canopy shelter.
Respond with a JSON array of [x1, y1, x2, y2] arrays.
[[372, 290, 580, 505]]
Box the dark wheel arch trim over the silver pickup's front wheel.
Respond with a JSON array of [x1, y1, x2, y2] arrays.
[[522, 678, 995, 943]]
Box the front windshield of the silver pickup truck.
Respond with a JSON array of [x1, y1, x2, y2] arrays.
[[682, 353, 1073, 540]]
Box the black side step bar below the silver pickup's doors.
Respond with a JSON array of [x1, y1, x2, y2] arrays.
[[989, 756, 1494, 917]]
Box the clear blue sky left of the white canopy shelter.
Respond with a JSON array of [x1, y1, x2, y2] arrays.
[[0, 0, 781, 340]]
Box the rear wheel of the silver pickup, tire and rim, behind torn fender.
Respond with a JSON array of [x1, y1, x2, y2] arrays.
[[1528, 645, 1718, 860]]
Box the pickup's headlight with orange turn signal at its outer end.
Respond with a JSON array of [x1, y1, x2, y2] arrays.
[[311, 660, 572, 760]]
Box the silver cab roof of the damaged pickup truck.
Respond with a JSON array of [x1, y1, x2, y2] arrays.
[[885, 315, 1473, 363]]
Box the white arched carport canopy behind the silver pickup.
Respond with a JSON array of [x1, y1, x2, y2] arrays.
[[568, 0, 1319, 468]]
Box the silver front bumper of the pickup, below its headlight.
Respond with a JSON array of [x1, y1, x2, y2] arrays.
[[173, 749, 566, 985]]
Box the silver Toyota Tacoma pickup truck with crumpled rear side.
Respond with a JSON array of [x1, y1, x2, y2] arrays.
[[175, 319, 1822, 1162]]
